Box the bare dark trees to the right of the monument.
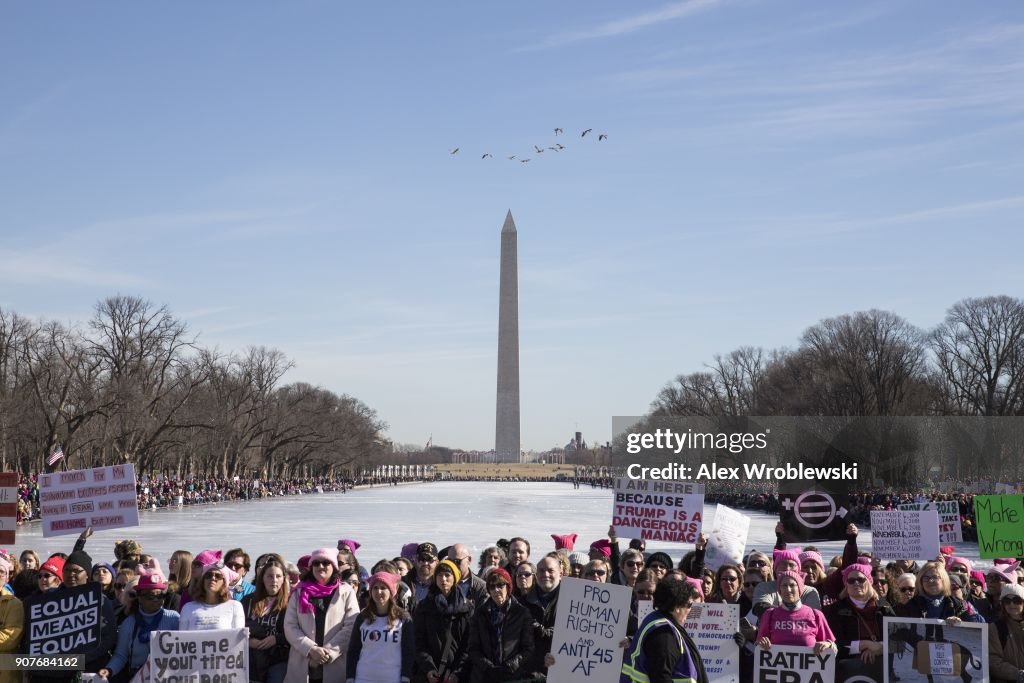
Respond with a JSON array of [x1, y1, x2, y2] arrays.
[[646, 296, 1024, 482]]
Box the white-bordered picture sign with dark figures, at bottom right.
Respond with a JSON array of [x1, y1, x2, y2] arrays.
[[882, 616, 989, 683]]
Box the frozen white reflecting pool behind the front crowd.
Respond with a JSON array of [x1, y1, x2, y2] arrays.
[[8, 481, 978, 569]]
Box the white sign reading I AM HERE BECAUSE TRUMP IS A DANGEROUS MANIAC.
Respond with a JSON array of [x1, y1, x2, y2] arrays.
[[611, 477, 703, 543]]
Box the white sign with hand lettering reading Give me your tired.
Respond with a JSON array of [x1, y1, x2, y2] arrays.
[[148, 629, 249, 683]]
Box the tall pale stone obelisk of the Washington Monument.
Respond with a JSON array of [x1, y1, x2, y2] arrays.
[[495, 211, 519, 463]]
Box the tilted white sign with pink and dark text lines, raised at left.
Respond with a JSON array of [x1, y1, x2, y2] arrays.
[[39, 464, 138, 538]]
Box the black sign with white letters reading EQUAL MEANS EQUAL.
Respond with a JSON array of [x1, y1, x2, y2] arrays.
[[22, 584, 103, 655]]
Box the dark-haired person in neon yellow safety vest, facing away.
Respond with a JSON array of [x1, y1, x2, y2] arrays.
[[621, 578, 708, 683]]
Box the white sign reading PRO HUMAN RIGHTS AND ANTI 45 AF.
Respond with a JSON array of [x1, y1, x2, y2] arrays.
[[548, 579, 633, 683]]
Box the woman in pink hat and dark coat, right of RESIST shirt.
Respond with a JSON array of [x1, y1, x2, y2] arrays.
[[824, 564, 896, 681]]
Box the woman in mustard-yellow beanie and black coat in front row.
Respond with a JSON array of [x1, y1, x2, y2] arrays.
[[413, 560, 471, 683]]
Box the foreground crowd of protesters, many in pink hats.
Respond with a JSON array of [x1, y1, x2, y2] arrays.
[[0, 524, 1024, 683]]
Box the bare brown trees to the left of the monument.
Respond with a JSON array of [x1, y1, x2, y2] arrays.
[[0, 295, 386, 478]]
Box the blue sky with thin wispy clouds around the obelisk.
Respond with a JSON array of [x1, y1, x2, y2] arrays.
[[0, 0, 1024, 450]]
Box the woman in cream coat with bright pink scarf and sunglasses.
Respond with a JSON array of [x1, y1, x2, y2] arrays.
[[285, 548, 359, 683]]
